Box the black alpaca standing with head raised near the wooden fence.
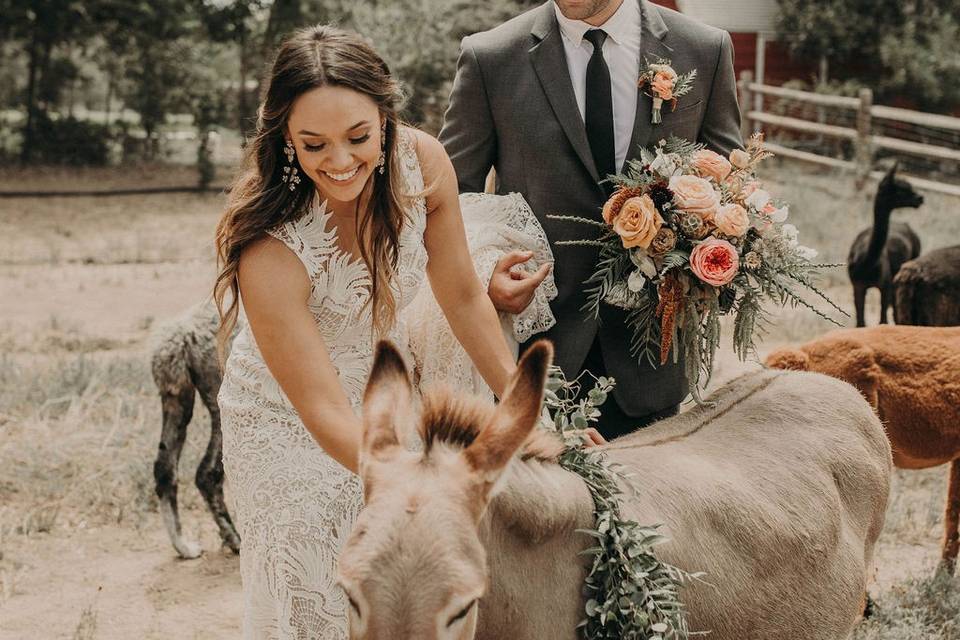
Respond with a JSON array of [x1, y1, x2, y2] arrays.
[[847, 164, 923, 327]]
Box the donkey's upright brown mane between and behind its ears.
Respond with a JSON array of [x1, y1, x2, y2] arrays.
[[419, 386, 564, 462]]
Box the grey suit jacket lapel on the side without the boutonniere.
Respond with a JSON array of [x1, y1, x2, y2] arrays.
[[530, 2, 600, 182]]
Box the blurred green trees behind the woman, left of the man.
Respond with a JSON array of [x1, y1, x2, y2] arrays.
[[0, 0, 540, 162]]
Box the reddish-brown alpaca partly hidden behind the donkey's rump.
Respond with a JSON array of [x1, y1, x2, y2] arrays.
[[766, 326, 960, 573]]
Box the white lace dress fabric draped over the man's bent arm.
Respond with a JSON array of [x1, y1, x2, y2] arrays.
[[460, 193, 557, 343]]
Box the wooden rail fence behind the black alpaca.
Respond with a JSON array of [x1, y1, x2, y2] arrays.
[[739, 71, 960, 196]]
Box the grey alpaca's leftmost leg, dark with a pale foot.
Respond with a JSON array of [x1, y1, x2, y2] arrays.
[[153, 386, 201, 558]]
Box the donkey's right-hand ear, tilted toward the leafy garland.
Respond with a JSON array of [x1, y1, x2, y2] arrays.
[[464, 340, 553, 486]]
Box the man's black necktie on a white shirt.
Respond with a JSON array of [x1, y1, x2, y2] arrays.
[[583, 29, 617, 193]]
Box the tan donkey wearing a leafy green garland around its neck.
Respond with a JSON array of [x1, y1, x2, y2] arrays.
[[339, 341, 891, 640]]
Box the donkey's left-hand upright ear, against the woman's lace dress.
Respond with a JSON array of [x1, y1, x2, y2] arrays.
[[360, 340, 411, 461]]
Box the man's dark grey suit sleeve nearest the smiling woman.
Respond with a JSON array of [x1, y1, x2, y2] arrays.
[[439, 38, 497, 193]]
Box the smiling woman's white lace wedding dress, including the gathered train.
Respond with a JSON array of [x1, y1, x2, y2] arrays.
[[219, 132, 555, 640]]
